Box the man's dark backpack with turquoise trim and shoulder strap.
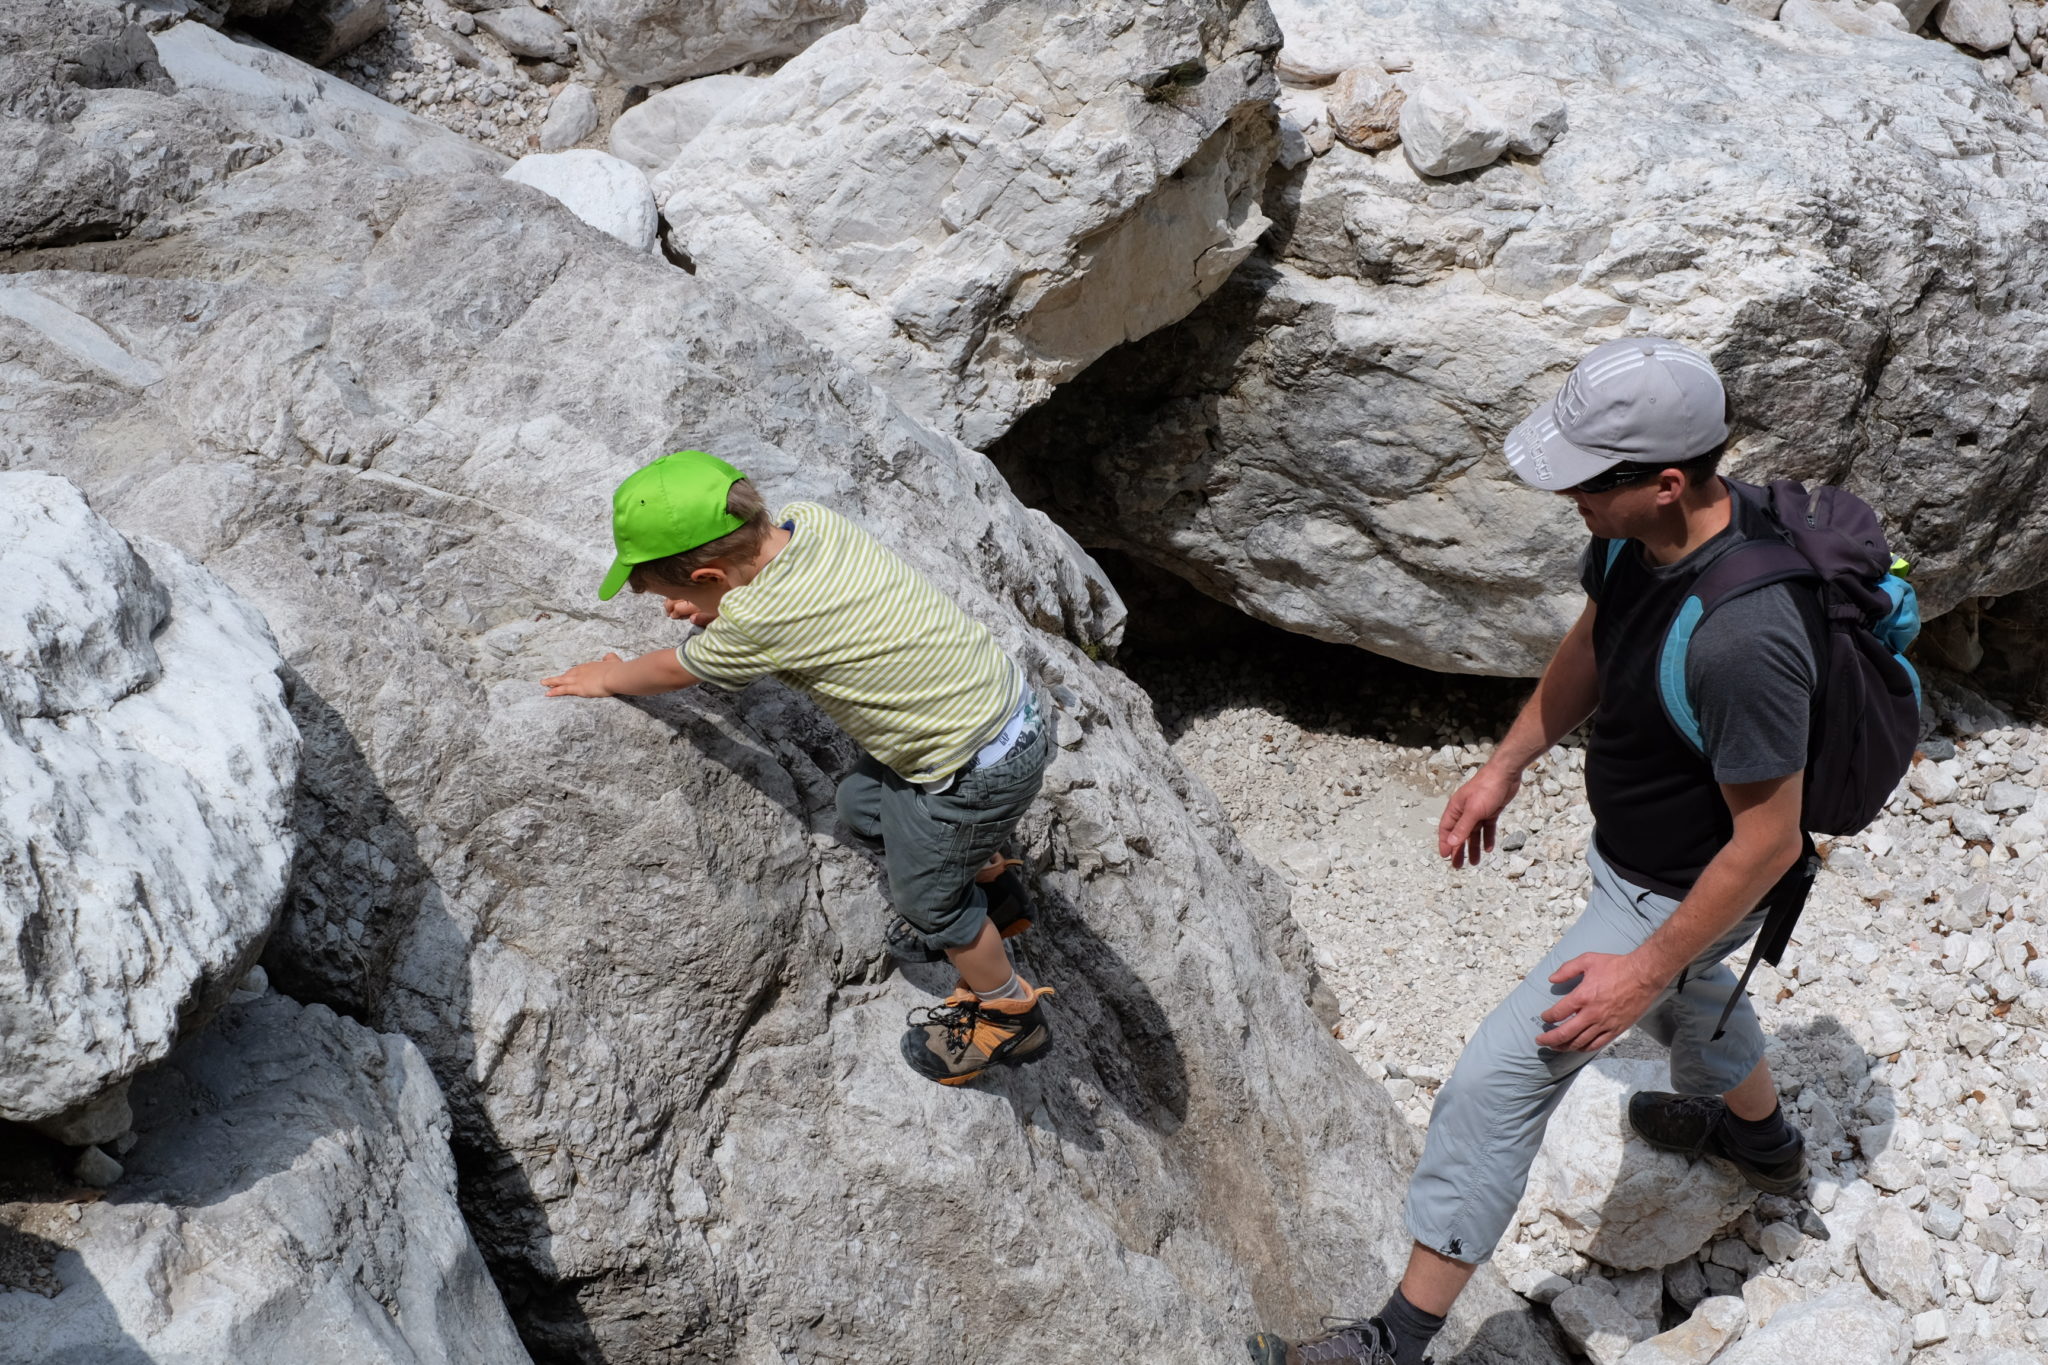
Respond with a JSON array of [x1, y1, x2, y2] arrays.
[[1608, 479, 1921, 1038]]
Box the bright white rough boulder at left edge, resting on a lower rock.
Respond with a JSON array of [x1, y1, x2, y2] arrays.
[[0, 474, 299, 1144]]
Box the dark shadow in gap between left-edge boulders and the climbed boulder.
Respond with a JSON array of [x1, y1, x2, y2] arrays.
[[264, 669, 604, 1365]]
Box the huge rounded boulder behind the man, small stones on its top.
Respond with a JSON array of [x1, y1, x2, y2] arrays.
[[993, 0, 2048, 673]]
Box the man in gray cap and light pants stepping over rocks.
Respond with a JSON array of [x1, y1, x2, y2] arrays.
[[1249, 338, 1817, 1365]]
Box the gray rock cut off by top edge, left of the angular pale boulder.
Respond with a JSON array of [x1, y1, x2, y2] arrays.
[[563, 0, 868, 86]]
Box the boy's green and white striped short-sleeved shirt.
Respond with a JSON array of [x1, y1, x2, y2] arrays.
[[676, 501, 1024, 782]]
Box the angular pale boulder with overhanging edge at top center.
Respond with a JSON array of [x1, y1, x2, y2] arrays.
[[655, 0, 1278, 446]]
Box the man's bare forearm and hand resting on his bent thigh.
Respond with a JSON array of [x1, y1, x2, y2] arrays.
[[1536, 772, 1806, 1052]]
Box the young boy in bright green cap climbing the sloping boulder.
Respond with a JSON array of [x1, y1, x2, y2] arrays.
[[545, 450, 1051, 1085]]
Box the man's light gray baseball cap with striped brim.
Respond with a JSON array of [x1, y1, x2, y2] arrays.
[[1507, 336, 1729, 491]]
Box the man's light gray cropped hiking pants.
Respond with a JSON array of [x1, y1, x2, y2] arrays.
[[1407, 845, 1763, 1263]]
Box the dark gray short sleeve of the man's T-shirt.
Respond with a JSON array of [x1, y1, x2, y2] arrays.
[[1579, 524, 1821, 784]]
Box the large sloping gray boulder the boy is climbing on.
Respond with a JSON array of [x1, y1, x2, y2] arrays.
[[0, 13, 1563, 1365]]
